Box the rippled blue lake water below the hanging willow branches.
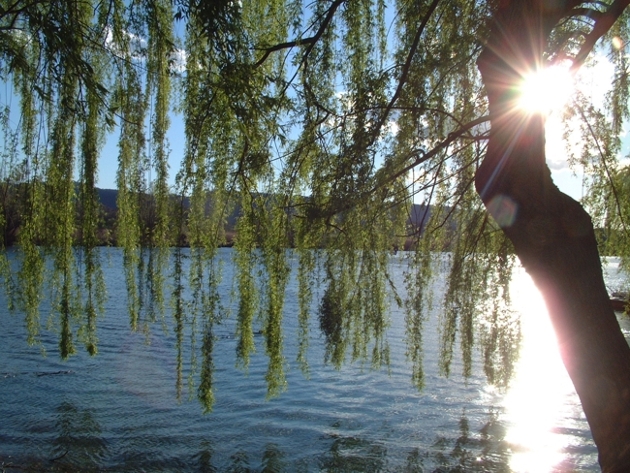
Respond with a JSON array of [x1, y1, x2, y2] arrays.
[[0, 249, 630, 473]]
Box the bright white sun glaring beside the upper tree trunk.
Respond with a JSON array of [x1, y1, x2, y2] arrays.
[[518, 63, 575, 115]]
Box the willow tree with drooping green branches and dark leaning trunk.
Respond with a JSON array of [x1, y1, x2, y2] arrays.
[[0, 0, 630, 472]]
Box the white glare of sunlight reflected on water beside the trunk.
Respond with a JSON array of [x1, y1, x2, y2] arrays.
[[504, 271, 575, 473]]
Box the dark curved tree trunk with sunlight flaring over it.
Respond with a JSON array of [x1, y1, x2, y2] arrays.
[[475, 0, 630, 472]]
